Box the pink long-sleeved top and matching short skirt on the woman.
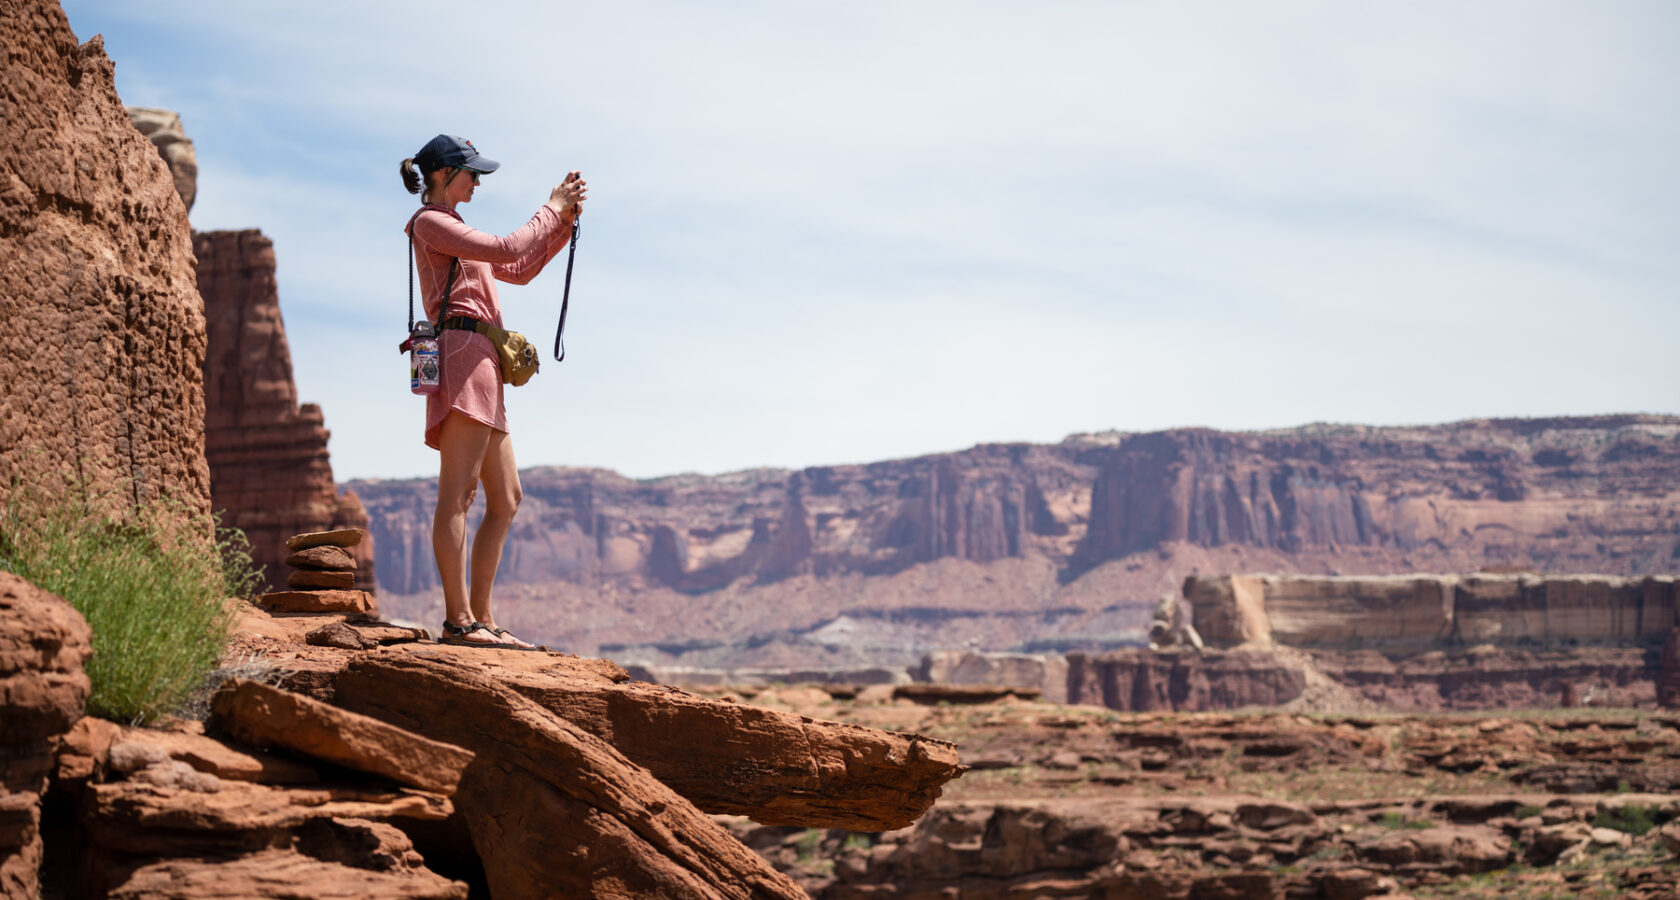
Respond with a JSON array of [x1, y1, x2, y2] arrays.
[[405, 203, 571, 448]]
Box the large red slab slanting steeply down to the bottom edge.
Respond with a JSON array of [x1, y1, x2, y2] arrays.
[[325, 658, 803, 898]]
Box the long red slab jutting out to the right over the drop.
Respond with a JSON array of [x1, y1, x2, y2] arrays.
[[334, 650, 964, 831]]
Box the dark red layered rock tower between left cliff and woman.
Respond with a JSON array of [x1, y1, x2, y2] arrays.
[[193, 230, 376, 591]]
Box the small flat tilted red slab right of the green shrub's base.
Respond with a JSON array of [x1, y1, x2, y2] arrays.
[[208, 678, 472, 794]]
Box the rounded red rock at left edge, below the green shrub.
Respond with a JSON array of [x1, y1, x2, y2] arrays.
[[0, 571, 92, 897]]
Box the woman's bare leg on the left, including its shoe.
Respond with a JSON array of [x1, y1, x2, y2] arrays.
[[432, 413, 493, 643]]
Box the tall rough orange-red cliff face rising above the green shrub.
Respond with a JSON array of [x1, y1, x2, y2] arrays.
[[0, 0, 210, 512]]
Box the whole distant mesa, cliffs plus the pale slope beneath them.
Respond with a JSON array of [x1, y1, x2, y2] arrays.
[[351, 415, 1680, 661]]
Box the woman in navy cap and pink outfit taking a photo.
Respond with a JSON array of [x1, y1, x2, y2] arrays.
[[402, 134, 586, 650]]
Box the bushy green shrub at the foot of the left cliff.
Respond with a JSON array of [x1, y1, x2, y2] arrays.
[[0, 487, 259, 724]]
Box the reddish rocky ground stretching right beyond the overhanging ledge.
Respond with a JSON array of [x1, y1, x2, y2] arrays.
[[712, 687, 1680, 898]]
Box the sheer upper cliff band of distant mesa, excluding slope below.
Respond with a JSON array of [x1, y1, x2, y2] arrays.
[[351, 415, 1680, 594]]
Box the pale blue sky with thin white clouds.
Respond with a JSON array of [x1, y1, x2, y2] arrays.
[[66, 0, 1680, 480]]
